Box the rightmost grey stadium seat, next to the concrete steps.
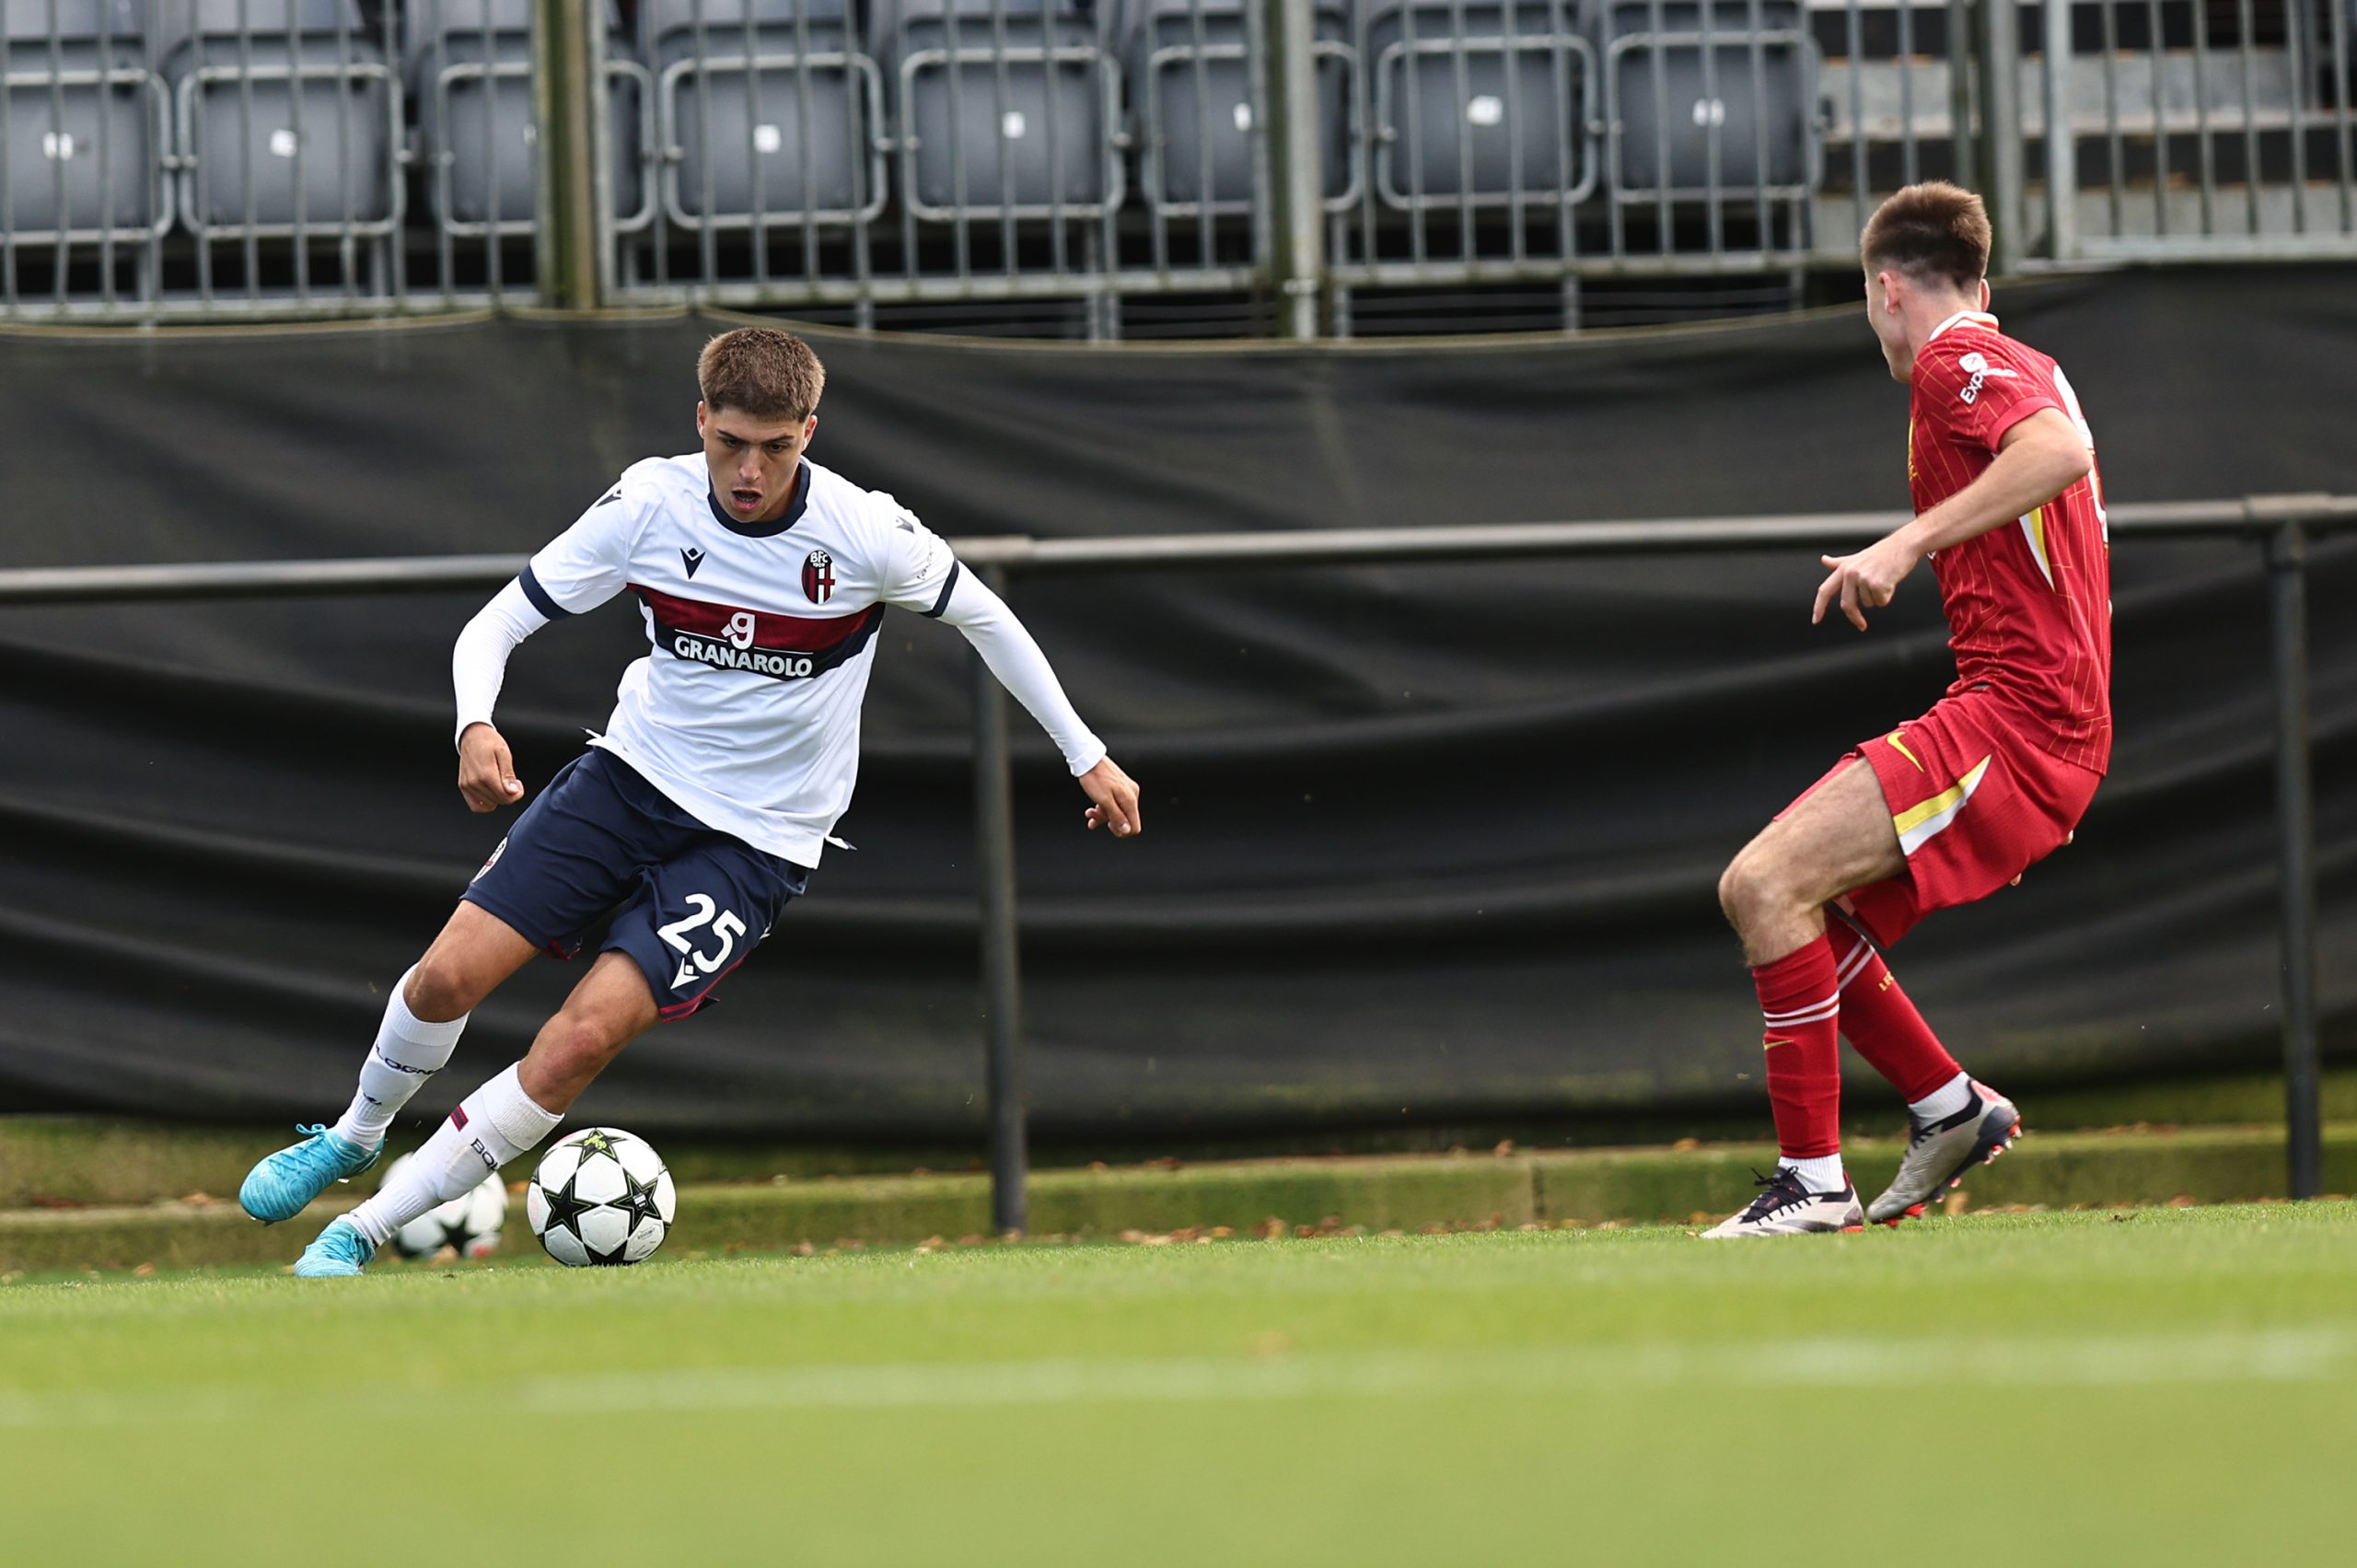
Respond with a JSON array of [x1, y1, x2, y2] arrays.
[[1596, 0, 1819, 201]]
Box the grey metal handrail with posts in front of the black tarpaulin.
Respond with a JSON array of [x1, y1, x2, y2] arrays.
[[0, 495, 2357, 1231]]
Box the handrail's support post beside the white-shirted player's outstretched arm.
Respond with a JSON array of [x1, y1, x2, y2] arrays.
[[967, 566, 1028, 1236]]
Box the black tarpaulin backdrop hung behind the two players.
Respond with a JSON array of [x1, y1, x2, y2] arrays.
[[0, 269, 2357, 1136]]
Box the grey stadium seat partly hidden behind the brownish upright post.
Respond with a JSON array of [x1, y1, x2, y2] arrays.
[[401, 0, 653, 236]]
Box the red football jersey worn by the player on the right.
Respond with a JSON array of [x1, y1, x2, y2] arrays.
[[1907, 311, 2112, 773]]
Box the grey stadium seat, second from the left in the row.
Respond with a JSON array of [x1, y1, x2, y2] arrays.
[[148, 0, 401, 238]]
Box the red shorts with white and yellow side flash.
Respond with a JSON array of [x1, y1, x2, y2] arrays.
[[1786, 691, 2103, 947]]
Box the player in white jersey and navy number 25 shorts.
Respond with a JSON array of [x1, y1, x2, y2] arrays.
[[238, 328, 1144, 1278]]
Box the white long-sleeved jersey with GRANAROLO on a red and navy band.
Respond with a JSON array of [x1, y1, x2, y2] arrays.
[[450, 453, 1106, 865]]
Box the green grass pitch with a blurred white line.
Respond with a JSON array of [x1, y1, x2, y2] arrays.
[[0, 1202, 2357, 1568]]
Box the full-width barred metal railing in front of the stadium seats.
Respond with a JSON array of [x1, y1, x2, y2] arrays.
[[0, 0, 2357, 327]]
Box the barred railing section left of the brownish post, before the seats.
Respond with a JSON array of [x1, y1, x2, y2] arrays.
[[0, 0, 565, 323]]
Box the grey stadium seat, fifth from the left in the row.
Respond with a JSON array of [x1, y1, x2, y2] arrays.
[[875, 0, 1122, 222]]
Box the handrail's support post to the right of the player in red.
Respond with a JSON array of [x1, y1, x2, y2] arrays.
[[2248, 497, 2324, 1198]]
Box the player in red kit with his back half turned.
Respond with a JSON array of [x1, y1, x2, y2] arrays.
[[1706, 181, 2112, 1237]]
